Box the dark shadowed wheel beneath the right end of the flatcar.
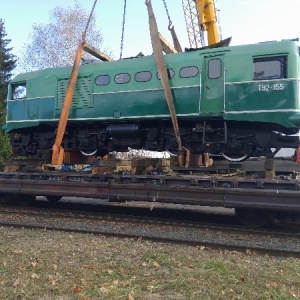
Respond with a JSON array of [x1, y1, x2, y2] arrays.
[[235, 208, 270, 227]]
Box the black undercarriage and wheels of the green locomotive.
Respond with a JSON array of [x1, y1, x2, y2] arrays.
[[11, 121, 298, 162]]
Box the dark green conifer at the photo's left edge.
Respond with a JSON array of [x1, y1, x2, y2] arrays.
[[0, 19, 16, 165]]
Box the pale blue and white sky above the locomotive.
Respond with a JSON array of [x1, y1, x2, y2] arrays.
[[0, 0, 300, 64]]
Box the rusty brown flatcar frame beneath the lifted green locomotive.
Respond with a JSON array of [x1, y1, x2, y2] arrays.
[[0, 173, 300, 212]]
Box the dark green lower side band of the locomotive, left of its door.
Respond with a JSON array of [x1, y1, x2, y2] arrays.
[[7, 87, 199, 131]]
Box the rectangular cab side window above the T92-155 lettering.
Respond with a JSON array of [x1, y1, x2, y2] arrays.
[[253, 56, 286, 80]]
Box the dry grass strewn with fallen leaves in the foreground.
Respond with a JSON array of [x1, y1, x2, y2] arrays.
[[0, 228, 300, 300]]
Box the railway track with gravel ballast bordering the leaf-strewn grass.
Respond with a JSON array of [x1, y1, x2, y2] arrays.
[[0, 206, 300, 257]]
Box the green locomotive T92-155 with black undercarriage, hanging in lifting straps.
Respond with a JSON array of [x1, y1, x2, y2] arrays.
[[3, 41, 300, 161]]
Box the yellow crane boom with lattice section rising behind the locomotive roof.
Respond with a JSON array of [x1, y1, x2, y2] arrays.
[[182, 0, 221, 48]]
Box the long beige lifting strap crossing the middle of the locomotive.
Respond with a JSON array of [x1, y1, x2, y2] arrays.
[[145, 0, 184, 166]]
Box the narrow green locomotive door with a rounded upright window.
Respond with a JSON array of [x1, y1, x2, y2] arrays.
[[200, 55, 225, 116]]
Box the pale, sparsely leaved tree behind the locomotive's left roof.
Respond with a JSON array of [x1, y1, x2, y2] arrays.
[[18, 2, 103, 71]]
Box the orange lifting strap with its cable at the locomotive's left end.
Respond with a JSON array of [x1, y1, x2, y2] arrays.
[[51, 0, 97, 165]]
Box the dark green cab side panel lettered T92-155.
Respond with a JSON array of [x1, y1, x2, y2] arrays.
[[225, 80, 298, 127]]
